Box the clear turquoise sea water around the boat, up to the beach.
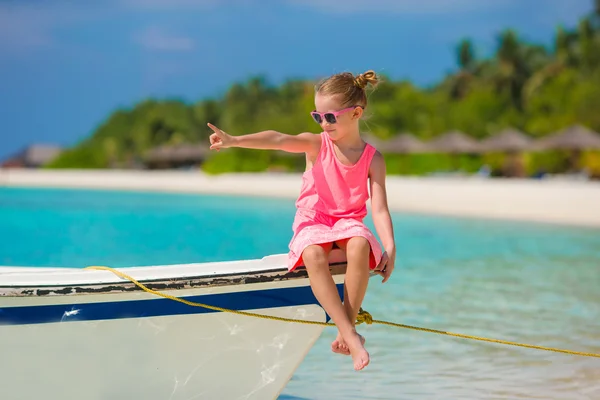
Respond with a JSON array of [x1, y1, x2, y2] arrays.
[[0, 188, 600, 400]]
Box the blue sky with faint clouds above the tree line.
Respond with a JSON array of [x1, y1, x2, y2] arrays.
[[0, 0, 592, 159]]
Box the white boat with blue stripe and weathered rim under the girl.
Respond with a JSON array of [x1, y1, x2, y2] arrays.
[[0, 252, 345, 400]]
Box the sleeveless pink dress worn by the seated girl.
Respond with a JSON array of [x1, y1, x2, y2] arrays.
[[288, 132, 382, 271]]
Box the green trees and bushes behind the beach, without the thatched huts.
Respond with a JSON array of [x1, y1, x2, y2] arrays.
[[48, 4, 600, 174]]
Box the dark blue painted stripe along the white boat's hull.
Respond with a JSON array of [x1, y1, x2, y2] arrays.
[[0, 284, 344, 325]]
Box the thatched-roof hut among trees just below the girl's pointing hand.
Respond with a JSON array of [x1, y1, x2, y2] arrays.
[[145, 144, 209, 168]]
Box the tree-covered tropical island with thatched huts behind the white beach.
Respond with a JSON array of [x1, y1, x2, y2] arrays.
[[45, 0, 600, 178]]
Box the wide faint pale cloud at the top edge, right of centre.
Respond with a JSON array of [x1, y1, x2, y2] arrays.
[[288, 0, 516, 14]]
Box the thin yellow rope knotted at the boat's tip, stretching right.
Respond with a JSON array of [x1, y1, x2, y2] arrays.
[[86, 266, 600, 358]]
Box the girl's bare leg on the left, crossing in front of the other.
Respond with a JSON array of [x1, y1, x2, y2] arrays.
[[302, 244, 370, 371]]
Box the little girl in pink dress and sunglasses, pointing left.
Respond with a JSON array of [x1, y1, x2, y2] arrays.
[[208, 71, 396, 370]]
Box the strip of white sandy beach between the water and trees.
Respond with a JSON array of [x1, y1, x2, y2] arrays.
[[0, 169, 600, 227]]
